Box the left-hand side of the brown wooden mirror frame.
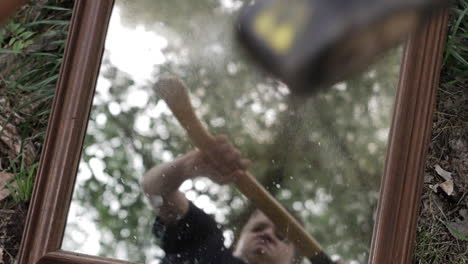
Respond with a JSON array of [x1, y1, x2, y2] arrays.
[[18, 0, 114, 264]]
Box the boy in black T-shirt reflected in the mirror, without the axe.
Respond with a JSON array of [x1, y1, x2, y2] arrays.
[[142, 136, 341, 264]]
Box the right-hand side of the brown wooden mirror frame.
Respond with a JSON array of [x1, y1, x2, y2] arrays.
[[369, 9, 448, 264]]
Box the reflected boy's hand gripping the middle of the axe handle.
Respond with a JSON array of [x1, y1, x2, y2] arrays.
[[189, 135, 251, 184]]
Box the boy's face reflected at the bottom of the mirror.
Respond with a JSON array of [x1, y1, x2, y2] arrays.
[[234, 211, 294, 264]]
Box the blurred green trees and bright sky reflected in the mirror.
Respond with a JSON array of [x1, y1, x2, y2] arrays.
[[62, 0, 401, 263]]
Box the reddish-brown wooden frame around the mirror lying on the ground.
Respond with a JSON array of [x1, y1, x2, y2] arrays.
[[19, 0, 448, 264]]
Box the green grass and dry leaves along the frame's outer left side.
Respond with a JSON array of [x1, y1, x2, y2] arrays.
[[0, 0, 73, 206]]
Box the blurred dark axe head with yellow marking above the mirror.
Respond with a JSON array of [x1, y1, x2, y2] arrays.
[[237, 0, 448, 94]]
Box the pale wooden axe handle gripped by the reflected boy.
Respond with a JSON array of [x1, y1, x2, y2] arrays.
[[155, 77, 333, 263]]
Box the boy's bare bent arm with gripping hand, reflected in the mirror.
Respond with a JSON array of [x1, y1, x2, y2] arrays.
[[142, 136, 250, 223]]
